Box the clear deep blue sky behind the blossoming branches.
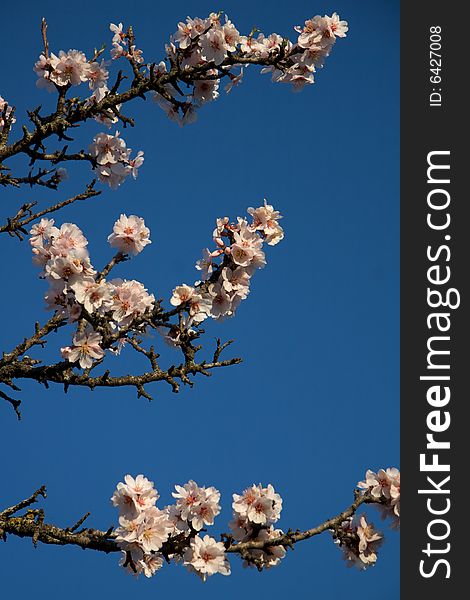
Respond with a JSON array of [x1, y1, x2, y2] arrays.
[[0, 0, 399, 600]]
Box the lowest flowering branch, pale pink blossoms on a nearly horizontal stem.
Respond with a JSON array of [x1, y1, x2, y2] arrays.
[[0, 469, 400, 580]]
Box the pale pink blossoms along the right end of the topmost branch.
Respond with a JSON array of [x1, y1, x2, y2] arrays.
[[154, 13, 348, 125]]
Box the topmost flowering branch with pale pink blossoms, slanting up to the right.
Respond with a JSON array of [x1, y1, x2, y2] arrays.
[[0, 13, 348, 185]]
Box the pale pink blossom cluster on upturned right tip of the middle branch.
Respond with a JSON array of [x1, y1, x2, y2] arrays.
[[166, 200, 284, 342]]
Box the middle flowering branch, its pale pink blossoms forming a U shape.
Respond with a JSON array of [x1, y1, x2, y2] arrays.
[[0, 199, 284, 417]]
